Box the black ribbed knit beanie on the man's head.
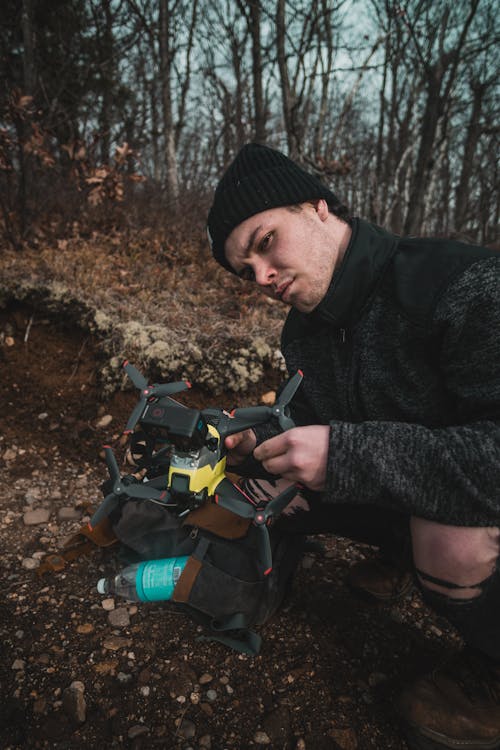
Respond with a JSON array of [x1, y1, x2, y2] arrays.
[[207, 143, 339, 273]]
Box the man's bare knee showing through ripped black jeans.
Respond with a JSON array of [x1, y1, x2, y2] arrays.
[[410, 517, 500, 599]]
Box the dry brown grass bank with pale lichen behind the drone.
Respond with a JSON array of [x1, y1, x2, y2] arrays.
[[0, 226, 286, 391]]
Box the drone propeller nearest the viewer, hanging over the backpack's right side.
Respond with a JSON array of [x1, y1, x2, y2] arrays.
[[215, 479, 300, 576]]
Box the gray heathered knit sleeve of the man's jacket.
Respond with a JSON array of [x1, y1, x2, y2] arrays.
[[324, 256, 500, 526]]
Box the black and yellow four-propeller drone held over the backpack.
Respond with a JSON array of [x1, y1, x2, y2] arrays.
[[89, 360, 303, 575]]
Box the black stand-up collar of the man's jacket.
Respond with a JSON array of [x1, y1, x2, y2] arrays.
[[311, 219, 398, 328]]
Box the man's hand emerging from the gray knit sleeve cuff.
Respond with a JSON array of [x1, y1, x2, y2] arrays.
[[254, 425, 330, 491]]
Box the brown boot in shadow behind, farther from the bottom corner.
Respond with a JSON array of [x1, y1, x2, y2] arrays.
[[346, 557, 412, 603]]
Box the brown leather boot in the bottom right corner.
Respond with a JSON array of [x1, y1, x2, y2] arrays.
[[399, 648, 500, 750]]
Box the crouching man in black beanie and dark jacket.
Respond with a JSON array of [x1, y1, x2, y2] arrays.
[[208, 144, 500, 750]]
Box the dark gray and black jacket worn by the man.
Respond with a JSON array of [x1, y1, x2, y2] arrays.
[[256, 219, 500, 526]]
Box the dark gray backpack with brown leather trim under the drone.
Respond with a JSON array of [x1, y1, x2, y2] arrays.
[[110, 500, 306, 655]]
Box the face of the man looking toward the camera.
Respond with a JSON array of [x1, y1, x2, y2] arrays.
[[225, 201, 341, 313]]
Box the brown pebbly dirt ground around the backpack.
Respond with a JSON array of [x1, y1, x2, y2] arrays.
[[0, 306, 462, 750]]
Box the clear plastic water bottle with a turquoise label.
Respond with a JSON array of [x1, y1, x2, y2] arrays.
[[97, 556, 189, 602]]
